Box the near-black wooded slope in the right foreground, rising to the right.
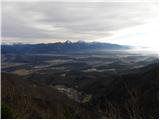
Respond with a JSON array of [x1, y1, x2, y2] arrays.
[[93, 64, 159, 118]]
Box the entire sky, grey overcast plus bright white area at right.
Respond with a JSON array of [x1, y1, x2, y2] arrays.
[[1, 0, 159, 48]]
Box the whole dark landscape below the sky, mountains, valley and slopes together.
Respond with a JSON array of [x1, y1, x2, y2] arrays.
[[1, 41, 159, 118]]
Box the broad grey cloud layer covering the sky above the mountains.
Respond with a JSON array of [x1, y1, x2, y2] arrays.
[[2, 1, 157, 43]]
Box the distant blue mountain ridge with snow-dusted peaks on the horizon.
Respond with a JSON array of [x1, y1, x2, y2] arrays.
[[1, 40, 131, 54]]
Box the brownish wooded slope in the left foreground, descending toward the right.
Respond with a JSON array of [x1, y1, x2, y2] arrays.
[[2, 73, 95, 118]]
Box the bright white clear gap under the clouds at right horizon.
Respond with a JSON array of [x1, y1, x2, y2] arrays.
[[95, 17, 160, 51]]
